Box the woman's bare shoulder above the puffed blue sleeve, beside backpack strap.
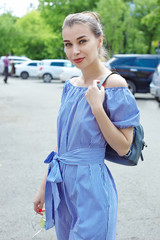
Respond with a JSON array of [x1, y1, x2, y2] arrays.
[[105, 73, 128, 88]]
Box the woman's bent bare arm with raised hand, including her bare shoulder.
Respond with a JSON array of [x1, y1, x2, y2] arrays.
[[86, 75, 133, 156]]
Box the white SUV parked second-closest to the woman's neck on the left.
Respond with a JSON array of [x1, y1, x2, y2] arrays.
[[38, 59, 73, 82]]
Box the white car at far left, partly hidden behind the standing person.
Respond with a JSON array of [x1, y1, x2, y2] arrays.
[[0, 56, 30, 74]]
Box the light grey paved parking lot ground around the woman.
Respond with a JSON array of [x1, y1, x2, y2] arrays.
[[0, 76, 160, 240]]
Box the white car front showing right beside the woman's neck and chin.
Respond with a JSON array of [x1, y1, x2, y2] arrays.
[[60, 67, 82, 83]]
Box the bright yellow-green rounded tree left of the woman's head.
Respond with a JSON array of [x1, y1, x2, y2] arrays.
[[16, 10, 57, 59]]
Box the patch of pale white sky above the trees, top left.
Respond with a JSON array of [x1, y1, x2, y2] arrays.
[[0, 0, 38, 17]]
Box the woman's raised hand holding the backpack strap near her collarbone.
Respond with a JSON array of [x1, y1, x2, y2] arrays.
[[85, 80, 105, 112]]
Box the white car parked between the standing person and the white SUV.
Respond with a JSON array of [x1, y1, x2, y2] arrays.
[[15, 60, 41, 79]]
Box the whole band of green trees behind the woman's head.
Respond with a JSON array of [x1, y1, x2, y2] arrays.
[[0, 0, 160, 59]]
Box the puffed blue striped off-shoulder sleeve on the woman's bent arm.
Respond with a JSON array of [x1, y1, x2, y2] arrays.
[[104, 87, 140, 128]]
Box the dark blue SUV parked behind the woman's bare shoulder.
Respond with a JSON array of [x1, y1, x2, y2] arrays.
[[107, 54, 160, 94]]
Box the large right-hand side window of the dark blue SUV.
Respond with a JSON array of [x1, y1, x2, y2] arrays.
[[134, 58, 158, 68]]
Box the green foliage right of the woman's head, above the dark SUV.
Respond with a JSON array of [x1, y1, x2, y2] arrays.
[[97, 0, 160, 55]]
